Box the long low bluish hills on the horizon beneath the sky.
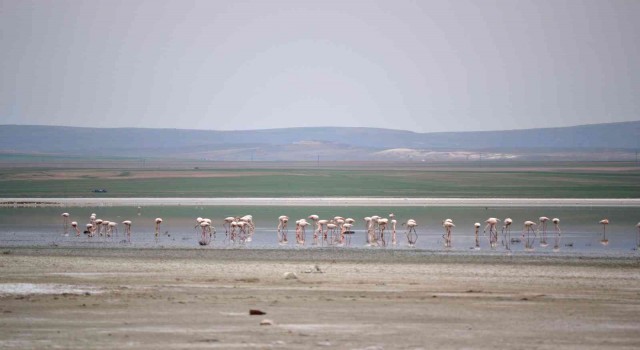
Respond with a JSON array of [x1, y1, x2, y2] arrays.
[[0, 121, 640, 160]]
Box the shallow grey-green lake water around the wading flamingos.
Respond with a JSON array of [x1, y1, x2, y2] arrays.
[[0, 206, 640, 255]]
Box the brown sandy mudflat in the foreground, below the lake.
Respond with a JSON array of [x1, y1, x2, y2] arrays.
[[0, 248, 640, 349]]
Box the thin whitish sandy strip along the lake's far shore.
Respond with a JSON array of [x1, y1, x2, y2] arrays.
[[0, 197, 640, 207]]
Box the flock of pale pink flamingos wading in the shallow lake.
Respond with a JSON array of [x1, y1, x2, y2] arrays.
[[62, 213, 640, 251]]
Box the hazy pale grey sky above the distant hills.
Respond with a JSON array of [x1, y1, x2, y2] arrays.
[[0, 0, 640, 132]]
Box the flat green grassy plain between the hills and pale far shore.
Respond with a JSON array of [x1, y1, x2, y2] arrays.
[[0, 161, 640, 198]]
